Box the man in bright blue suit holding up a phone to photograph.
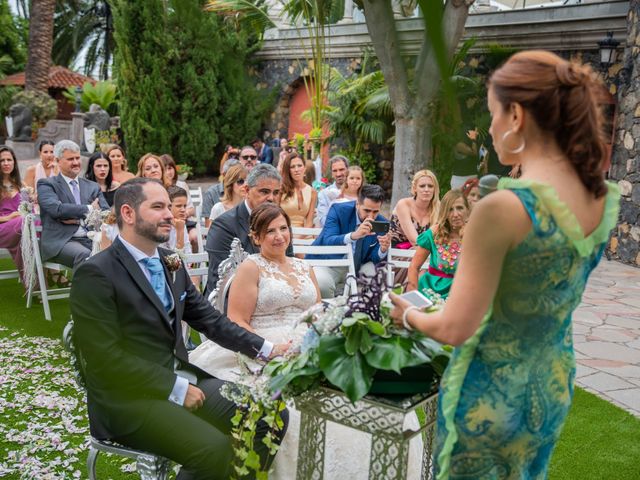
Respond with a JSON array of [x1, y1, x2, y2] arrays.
[[308, 185, 391, 298]]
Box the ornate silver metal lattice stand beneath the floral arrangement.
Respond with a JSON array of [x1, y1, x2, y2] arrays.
[[295, 387, 438, 480]]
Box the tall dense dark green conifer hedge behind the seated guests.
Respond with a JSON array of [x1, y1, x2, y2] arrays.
[[113, 0, 264, 173]]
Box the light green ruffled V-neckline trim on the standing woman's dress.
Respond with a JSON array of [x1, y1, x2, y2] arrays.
[[498, 177, 620, 257]]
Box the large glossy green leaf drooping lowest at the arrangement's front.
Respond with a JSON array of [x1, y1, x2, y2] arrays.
[[318, 337, 375, 402]]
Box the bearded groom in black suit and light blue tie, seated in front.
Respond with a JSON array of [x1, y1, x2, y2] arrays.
[[71, 178, 286, 480]]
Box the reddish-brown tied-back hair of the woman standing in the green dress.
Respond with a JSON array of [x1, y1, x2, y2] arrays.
[[489, 50, 607, 198]]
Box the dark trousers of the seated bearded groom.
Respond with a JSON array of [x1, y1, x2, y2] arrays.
[[114, 378, 286, 480]]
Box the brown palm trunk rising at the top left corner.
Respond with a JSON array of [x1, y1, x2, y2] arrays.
[[25, 0, 56, 93]]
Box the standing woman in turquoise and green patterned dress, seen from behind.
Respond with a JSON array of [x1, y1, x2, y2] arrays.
[[392, 51, 619, 480]]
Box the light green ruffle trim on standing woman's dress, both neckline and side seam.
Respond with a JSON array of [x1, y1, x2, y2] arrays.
[[437, 178, 620, 480]]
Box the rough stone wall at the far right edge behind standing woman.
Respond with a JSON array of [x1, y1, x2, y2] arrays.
[[610, 0, 640, 266]]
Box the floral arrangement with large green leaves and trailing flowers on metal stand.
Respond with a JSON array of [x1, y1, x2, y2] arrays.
[[223, 265, 450, 478]]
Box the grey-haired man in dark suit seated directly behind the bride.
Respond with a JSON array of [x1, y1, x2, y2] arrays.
[[204, 163, 282, 296]]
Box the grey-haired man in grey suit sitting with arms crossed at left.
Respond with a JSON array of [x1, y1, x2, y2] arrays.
[[37, 140, 109, 269]]
